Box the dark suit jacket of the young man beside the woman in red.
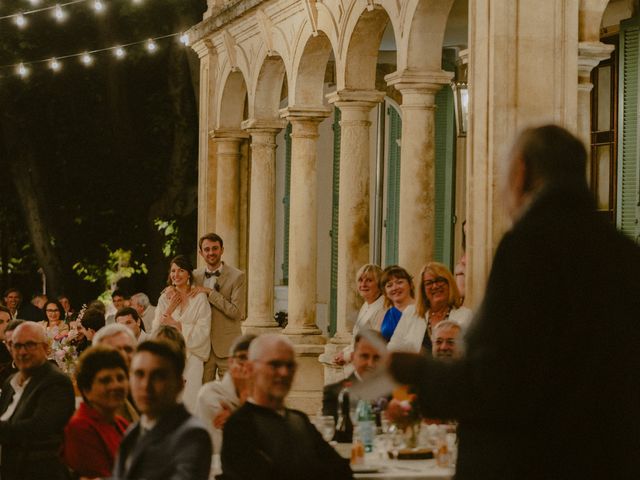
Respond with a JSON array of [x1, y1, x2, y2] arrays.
[[112, 404, 213, 480]]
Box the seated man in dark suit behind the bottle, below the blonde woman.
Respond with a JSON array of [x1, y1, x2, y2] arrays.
[[322, 330, 385, 420]]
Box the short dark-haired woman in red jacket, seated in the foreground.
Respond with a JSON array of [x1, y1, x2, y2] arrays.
[[63, 345, 129, 478]]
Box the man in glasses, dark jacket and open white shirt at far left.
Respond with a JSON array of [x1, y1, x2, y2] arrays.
[[0, 322, 75, 480]]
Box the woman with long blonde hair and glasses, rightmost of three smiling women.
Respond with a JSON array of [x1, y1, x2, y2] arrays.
[[416, 262, 472, 352]]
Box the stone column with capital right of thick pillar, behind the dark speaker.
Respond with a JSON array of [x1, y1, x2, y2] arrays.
[[578, 42, 614, 153]]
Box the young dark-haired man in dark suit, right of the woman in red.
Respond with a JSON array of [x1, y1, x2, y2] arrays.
[[112, 340, 212, 480]]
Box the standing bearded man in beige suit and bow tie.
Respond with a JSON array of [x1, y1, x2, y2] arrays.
[[192, 233, 246, 383]]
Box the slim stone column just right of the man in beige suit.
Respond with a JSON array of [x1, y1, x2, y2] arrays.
[[242, 119, 285, 334]]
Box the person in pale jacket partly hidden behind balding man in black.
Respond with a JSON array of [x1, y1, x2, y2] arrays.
[[196, 335, 256, 453]]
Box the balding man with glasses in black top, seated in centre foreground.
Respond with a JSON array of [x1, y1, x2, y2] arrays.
[[218, 334, 352, 480]]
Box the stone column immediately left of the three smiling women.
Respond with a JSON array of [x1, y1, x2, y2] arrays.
[[321, 90, 384, 383]]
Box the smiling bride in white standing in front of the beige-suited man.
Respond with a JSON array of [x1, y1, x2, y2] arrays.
[[152, 255, 211, 413]]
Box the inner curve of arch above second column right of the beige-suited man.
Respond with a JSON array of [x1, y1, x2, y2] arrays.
[[289, 31, 333, 106]]
